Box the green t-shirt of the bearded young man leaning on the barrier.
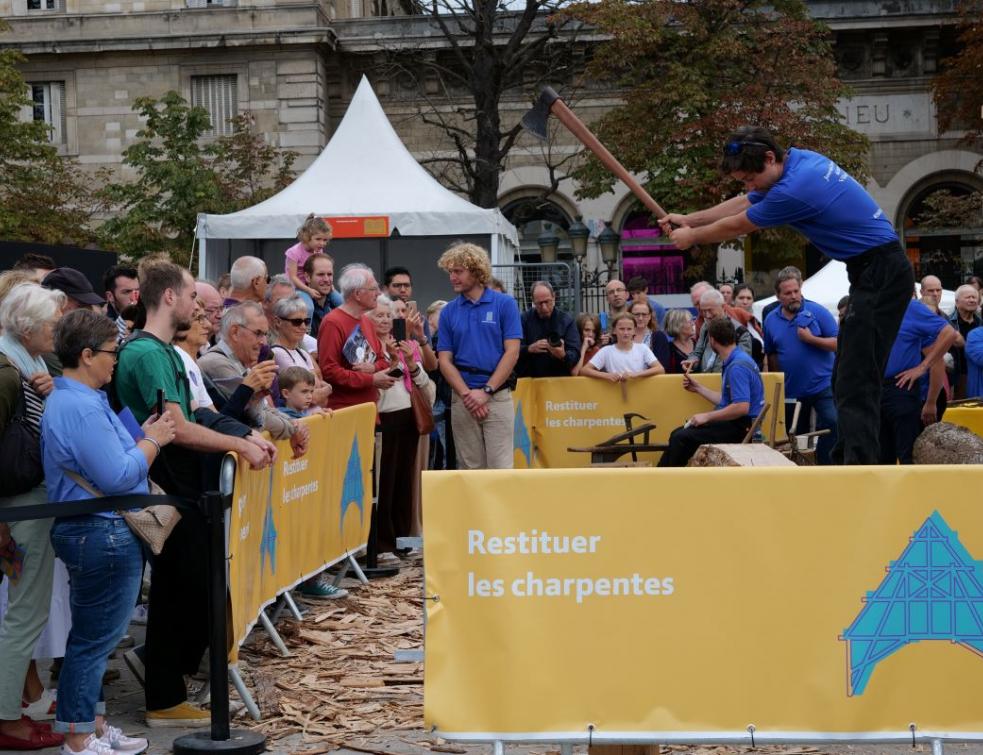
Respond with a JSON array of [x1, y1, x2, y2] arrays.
[[115, 331, 195, 424]]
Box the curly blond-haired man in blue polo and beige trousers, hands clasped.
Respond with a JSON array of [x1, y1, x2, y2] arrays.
[[437, 243, 522, 469]]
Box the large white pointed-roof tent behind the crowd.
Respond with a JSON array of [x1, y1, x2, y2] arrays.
[[190, 77, 518, 286]]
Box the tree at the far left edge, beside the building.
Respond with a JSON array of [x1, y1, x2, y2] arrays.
[[0, 39, 96, 244]]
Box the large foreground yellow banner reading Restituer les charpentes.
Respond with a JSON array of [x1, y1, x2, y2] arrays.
[[424, 467, 983, 742]]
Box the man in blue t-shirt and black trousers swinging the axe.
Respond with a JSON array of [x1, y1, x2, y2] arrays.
[[659, 126, 914, 464]]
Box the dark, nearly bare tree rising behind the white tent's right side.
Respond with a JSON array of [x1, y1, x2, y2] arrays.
[[374, 0, 573, 207]]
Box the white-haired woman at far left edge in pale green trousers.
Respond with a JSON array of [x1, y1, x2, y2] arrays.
[[0, 283, 64, 750]]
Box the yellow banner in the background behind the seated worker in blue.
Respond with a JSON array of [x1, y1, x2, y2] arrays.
[[512, 372, 786, 469]]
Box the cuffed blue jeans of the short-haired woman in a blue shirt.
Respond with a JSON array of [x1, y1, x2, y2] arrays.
[[51, 516, 143, 734]]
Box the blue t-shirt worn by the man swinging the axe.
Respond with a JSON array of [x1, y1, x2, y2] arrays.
[[747, 148, 898, 260]]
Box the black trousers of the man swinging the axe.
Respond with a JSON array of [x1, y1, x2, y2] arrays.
[[832, 242, 915, 464]]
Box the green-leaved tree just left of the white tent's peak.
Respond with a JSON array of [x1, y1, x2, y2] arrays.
[[100, 91, 296, 264]]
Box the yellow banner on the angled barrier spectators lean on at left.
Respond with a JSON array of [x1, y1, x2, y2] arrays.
[[229, 404, 376, 660]]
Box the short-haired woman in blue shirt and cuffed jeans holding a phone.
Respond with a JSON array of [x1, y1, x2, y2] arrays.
[[41, 309, 174, 755]]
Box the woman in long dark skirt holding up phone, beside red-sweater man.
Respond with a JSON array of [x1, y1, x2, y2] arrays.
[[371, 295, 436, 553]]
